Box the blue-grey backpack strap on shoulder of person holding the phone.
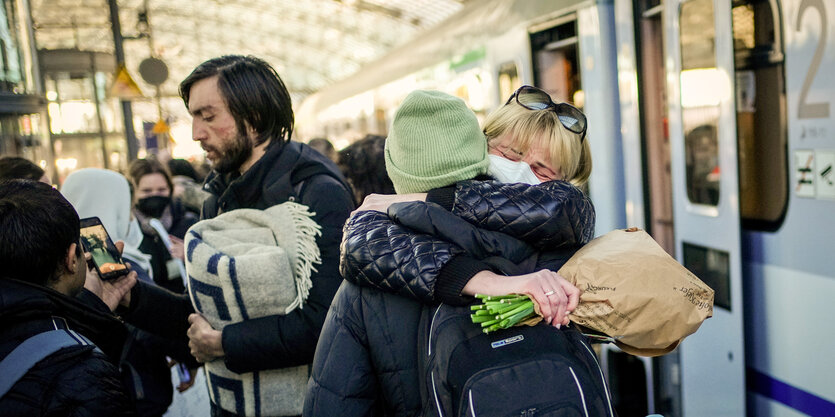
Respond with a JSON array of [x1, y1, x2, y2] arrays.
[[0, 329, 98, 398]]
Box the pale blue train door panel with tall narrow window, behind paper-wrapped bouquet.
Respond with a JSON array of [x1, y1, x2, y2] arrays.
[[665, 0, 745, 416]]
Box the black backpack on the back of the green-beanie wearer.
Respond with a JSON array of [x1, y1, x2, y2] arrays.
[[419, 305, 615, 417]]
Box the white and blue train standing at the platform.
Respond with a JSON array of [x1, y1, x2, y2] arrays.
[[297, 0, 835, 417]]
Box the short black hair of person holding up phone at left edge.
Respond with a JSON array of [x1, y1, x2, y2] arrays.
[[0, 180, 83, 286]]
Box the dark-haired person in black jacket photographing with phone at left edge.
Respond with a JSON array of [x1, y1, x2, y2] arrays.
[[0, 180, 135, 417]]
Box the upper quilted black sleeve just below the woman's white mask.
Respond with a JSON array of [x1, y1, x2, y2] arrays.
[[452, 181, 594, 250]]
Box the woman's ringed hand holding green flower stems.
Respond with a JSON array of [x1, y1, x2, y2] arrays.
[[462, 269, 580, 328]]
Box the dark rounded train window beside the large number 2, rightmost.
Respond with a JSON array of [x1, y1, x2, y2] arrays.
[[733, 0, 789, 230]]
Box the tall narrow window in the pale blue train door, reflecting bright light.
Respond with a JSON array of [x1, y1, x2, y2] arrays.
[[680, 0, 722, 206]]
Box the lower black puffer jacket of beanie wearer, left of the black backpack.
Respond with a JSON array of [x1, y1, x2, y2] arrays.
[[303, 281, 423, 417]]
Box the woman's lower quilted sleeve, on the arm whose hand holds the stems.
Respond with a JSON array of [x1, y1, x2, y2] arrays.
[[339, 211, 463, 303]]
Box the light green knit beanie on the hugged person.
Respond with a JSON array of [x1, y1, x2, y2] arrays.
[[385, 90, 489, 194]]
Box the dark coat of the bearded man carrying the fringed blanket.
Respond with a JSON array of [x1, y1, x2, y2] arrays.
[[126, 142, 354, 373]]
